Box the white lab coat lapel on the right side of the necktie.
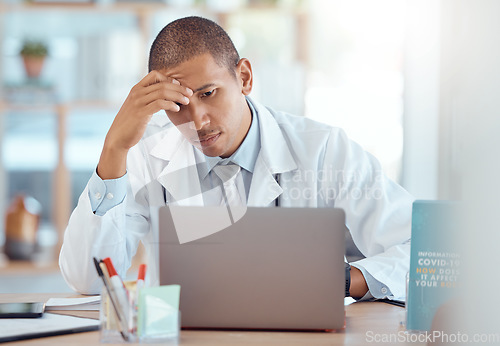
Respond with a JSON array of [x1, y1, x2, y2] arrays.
[[248, 98, 297, 207]]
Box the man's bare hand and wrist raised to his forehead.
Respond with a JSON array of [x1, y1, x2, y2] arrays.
[[97, 71, 193, 180]]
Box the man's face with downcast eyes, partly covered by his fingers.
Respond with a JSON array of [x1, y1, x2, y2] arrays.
[[161, 53, 252, 157]]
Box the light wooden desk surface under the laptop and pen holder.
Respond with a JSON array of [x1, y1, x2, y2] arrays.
[[0, 293, 423, 346]]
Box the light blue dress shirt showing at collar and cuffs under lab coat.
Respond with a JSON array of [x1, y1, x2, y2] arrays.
[[88, 96, 392, 300]]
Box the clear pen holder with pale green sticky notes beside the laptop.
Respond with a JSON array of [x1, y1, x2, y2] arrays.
[[100, 282, 181, 345]]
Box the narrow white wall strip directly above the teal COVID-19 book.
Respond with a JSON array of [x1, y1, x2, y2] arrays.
[[401, 0, 441, 199]]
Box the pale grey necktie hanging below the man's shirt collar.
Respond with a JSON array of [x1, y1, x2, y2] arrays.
[[213, 164, 246, 207]]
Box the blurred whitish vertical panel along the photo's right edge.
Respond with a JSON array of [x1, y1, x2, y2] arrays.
[[440, 0, 500, 336]]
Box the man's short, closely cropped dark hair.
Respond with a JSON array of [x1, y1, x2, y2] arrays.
[[149, 17, 240, 74]]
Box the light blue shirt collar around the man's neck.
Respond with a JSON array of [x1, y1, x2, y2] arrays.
[[195, 99, 260, 180]]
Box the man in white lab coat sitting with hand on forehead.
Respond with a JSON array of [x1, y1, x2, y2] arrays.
[[59, 17, 413, 299]]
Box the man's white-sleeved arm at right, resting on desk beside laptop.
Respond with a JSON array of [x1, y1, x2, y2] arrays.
[[324, 129, 414, 300]]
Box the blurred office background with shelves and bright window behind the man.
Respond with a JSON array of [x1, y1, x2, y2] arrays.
[[0, 0, 500, 322]]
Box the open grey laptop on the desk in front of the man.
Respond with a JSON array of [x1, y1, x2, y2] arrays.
[[159, 206, 345, 330]]
